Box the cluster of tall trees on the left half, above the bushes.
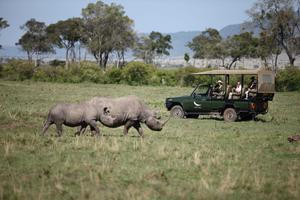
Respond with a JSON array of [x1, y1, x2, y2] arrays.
[[0, 1, 172, 69]]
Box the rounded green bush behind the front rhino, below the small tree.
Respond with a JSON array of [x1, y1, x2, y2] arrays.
[[123, 62, 155, 85]]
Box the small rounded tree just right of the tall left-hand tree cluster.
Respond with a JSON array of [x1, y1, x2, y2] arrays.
[[134, 31, 173, 64]]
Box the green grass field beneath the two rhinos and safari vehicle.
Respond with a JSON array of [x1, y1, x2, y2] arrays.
[[0, 81, 300, 199]]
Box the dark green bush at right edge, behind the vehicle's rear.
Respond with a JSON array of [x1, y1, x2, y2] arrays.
[[275, 67, 300, 91]]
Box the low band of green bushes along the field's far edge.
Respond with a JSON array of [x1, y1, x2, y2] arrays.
[[0, 60, 300, 91]]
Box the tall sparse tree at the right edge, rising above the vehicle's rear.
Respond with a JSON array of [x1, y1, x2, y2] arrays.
[[247, 0, 300, 65]]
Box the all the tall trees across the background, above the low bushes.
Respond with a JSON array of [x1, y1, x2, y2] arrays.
[[0, 0, 300, 71]]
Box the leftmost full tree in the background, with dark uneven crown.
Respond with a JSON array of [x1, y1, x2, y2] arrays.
[[16, 19, 54, 65]]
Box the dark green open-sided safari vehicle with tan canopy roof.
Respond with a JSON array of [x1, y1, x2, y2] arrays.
[[166, 69, 275, 121]]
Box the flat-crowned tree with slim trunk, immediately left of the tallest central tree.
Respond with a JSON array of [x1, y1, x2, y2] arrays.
[[47, 18, 83, 69]]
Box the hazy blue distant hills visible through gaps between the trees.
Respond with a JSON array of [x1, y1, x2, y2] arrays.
[[0, 23, 258, 59]]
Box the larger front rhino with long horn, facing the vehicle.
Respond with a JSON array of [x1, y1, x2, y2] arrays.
[[88, 96, 170, 136]]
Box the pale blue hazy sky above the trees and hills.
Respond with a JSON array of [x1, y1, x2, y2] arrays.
[[0, 0, 256, 45]]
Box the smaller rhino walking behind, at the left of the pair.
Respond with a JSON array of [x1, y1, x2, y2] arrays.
[[42, 102, 114, 136]]
